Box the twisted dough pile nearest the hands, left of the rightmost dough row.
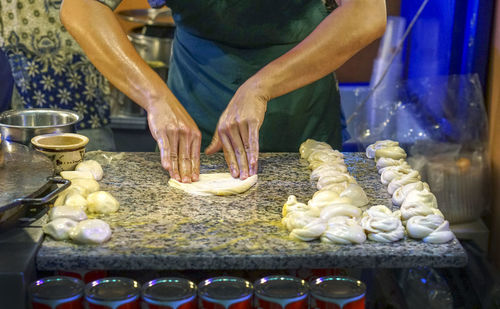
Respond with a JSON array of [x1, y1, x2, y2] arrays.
[[282, 139, 368, 244]]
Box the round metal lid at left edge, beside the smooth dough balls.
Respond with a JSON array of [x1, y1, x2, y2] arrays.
[[0, 141, 54, 211]]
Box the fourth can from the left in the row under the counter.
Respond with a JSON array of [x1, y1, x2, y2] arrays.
[[198, 276, 253, 309]]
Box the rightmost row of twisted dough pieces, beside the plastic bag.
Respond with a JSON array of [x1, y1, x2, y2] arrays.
[[366, 140, 454, 243]]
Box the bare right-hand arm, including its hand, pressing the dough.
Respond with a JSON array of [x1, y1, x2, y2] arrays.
[[206, 0, 386, 179]]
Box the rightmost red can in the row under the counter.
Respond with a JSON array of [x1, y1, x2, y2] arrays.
[[310, 276, 366, 309]]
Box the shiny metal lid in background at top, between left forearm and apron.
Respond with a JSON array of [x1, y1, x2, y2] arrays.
[[118, 8, 175, 27]]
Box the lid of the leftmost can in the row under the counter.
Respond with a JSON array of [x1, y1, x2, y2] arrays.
[[29, 276, 85, 300]]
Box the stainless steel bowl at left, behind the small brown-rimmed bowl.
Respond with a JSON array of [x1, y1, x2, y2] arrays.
[[0, 108, 82, 145]]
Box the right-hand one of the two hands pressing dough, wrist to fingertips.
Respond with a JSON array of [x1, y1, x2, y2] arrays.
[[205, 81, 268, 180]]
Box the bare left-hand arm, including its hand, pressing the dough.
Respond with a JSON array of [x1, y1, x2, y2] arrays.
[[60, 0, 201, 182]]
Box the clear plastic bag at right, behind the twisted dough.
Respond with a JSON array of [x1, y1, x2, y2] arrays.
[[348, 75, 489, 224]]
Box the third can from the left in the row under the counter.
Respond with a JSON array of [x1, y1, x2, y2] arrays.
[[141, 278, 198, 309]]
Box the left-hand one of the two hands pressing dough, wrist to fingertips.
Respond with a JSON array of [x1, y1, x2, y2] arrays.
[[147, 100, 201, 183]]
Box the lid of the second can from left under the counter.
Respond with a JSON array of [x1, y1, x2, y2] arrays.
[[85, 277, 140, 301]]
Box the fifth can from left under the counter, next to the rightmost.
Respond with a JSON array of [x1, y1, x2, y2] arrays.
[[254, 276, 309, 309]]
